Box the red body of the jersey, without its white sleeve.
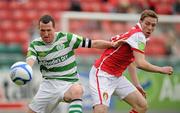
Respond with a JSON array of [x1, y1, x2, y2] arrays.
[[94, 25, 144, 77]]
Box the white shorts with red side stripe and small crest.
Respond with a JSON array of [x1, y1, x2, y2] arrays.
[[89, 66, 136, 106]]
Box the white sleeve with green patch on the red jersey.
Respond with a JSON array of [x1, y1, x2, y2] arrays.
[[126, 32, 146, 53]]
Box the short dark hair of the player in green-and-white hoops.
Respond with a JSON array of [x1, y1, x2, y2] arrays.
[[39, 15, 55, 27]]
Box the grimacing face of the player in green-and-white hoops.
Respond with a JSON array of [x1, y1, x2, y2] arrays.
[[39, 21, 55, 43]]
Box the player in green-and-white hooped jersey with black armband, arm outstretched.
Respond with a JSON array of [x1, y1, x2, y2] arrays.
[[26, 15, 121, 113]]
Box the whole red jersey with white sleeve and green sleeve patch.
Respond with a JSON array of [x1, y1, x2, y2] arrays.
[[94, 23, 146, 77]]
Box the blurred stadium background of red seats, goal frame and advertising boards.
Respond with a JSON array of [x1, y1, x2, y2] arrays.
[[0, 0, 180, 113]]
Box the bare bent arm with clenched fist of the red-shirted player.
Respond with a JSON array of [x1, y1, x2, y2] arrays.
[[133, 51, 173, 75]]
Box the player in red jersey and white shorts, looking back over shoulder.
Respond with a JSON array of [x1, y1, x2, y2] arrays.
[[89, 10, 173, 113]]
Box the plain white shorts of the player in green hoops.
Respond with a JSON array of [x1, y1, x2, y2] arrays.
[[29, 80, 77, 113]]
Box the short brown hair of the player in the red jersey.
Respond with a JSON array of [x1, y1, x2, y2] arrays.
[[140, 9, 158, 21]]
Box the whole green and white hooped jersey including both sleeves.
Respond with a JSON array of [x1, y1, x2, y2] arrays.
[[27, 32, 91, 82]]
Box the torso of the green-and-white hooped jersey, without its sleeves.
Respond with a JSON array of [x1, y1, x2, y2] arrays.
[[30, 32, 77, 77]]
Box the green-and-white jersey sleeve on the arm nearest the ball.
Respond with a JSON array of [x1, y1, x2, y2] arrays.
[[26, 42, 37, 60]]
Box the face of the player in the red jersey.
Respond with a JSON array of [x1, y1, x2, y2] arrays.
[[140, 17, 157, 38]]
